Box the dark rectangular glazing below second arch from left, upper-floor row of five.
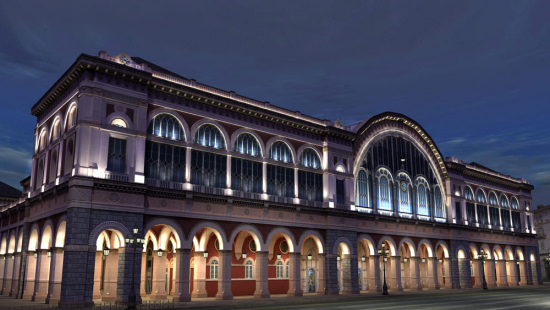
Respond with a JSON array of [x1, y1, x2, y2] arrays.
[[191, 150, 227, 188]]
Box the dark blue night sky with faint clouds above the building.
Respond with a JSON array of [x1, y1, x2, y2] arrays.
[[0, 0, 550, 205]]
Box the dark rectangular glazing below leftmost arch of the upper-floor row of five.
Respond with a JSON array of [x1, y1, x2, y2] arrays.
[[145, 141, 186, 182]]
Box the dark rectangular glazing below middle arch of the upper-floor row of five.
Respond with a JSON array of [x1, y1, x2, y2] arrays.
[[231, 157, 263, 193]]
